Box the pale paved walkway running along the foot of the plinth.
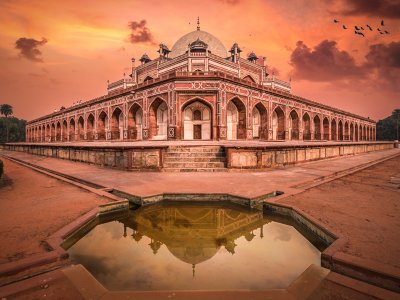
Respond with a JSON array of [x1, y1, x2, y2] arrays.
[[0, 149, 400, 198]]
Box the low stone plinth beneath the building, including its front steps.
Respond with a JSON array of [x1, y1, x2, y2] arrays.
[[0, 141, 395, 172]]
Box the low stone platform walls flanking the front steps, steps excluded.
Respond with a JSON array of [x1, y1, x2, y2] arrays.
[[0, 142, 396, 171]]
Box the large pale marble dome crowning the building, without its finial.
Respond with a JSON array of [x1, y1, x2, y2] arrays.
[[169, 30, 228, 58]]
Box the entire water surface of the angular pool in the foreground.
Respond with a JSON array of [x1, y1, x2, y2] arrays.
[[68, 202, 320, 290]]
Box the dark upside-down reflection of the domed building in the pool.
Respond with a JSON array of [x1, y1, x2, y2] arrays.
[[119, 203, 269, 276]]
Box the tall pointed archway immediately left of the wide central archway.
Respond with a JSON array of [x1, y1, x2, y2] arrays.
[[149, 98, 168, 140]]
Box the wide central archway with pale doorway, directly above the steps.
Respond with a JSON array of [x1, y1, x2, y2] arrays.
[[183, 100, 212, 140]]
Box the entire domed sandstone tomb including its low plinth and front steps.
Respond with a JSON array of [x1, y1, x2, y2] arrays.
[[13, 24, 394, 172]]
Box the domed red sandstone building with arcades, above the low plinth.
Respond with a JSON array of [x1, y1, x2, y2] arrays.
[[26, 27, 376, 142]]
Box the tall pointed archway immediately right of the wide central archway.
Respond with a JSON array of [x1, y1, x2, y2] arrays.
[[226, 98, 246, 140]]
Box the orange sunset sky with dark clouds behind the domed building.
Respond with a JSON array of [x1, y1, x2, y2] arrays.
[[0, 0, 400, 120]]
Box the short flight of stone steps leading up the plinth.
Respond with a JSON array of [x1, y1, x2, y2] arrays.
[[163, 146, 227, 172]]
